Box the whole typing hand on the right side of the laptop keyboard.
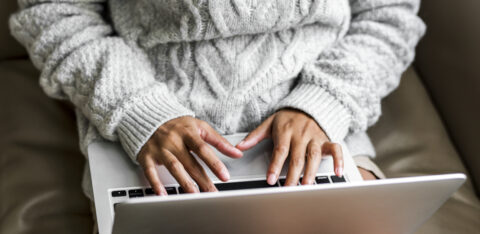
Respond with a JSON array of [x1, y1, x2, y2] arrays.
[[236, 109, 343, 186]]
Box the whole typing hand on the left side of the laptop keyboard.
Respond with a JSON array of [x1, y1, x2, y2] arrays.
[[137, 116, 242, 195]]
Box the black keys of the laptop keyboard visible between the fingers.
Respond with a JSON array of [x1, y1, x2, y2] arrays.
[[111, 175, 347, 198]]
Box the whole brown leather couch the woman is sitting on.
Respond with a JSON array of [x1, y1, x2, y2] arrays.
[[0, 0, 480, 234]]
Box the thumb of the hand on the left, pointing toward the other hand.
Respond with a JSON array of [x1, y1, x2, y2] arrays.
[[199, 123, 243, 158]]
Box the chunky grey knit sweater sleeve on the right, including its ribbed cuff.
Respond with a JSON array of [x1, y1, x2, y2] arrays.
[[276, 0, 425, 141]]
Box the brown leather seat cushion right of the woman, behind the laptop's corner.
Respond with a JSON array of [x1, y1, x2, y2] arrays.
[[369, 67, 480, 234]]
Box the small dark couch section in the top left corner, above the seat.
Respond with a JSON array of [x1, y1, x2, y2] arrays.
[[0, 0, 27, 61]]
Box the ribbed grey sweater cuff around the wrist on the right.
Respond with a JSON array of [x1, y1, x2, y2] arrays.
[[275, 83, 351, 142]]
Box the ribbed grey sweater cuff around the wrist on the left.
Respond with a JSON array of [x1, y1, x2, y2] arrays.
[[117, 86, 195, 164]]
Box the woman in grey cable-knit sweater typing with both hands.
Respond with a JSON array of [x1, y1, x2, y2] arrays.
[[10, 0, 425, 197]]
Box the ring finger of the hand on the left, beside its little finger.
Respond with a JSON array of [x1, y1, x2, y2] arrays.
[[162, 150, 199, 193]]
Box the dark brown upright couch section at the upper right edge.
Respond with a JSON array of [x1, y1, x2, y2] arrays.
[[416, 0, 480, 197]]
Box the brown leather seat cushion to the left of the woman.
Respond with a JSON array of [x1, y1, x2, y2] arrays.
[[0, 61, 93, 234]]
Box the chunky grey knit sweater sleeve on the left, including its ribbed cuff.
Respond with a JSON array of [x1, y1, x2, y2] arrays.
[[10, 0, 194, 161]]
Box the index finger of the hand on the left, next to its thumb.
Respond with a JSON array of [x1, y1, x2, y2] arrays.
[[185, 134, 230, 181]]
